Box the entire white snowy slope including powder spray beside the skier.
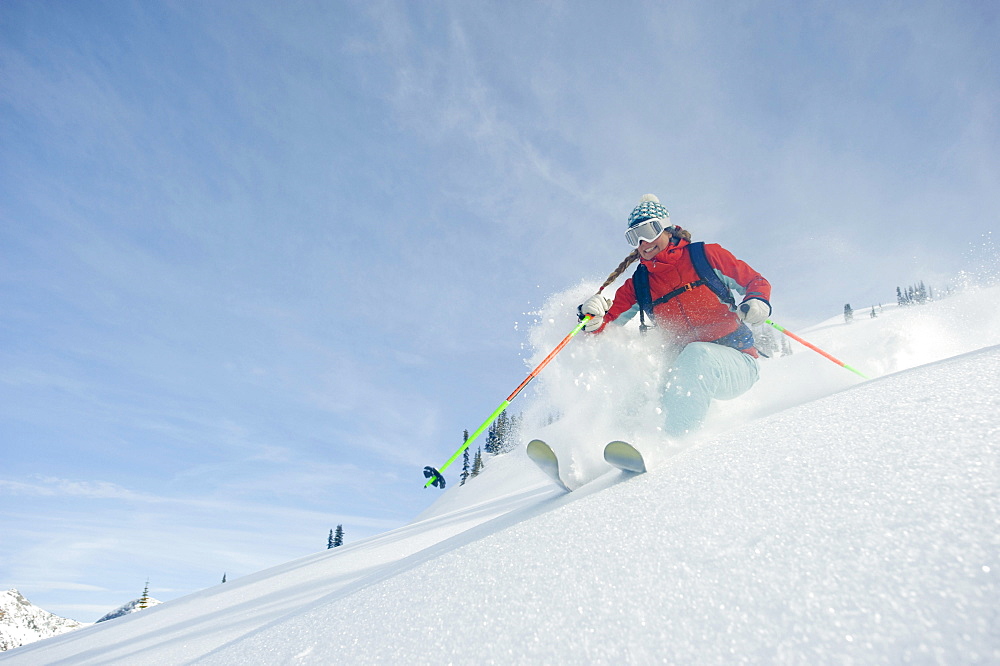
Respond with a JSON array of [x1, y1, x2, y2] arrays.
[[0, 282, 1000, 664]]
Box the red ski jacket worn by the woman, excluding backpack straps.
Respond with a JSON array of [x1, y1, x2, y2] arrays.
[[595, 240, 771, 357]]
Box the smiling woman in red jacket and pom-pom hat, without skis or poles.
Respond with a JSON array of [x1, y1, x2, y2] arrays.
[[579, 194, 771, 437]]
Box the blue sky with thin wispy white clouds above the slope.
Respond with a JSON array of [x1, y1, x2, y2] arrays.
[[0, 0, 1000, 620]]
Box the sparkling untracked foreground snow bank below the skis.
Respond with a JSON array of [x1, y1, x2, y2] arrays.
[[209, 347, 1000, 663]]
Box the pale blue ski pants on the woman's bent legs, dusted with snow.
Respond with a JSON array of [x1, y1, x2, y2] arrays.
[[660, 342, 760, 437]]
